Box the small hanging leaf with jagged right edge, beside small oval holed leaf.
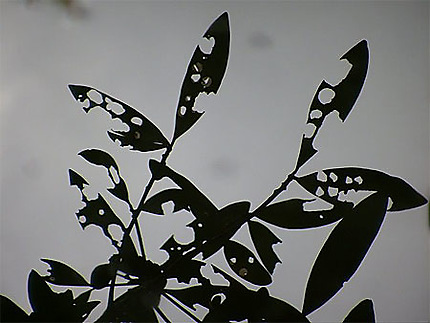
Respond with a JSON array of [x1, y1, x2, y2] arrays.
[[248, 221, 282, 274]]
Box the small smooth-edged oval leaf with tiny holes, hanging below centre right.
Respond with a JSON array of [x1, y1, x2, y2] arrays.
[[224, 240, 272, 286]]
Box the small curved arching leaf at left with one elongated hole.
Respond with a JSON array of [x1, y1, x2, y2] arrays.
[[78, 149, 131, 207]]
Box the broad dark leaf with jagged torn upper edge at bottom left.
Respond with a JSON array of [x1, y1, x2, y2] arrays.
[[28, 270, 100, 322]]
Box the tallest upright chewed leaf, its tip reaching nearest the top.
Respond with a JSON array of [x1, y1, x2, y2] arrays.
[[173, 12, 230, 140]]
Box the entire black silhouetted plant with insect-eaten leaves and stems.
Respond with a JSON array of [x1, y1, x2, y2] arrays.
[[1, 13, 427, 322]]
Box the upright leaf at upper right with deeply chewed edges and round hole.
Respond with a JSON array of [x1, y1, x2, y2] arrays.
[[296, 40, 369, 168]]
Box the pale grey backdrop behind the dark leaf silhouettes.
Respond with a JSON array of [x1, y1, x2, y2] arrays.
[[0, 0, 430, 322]]
